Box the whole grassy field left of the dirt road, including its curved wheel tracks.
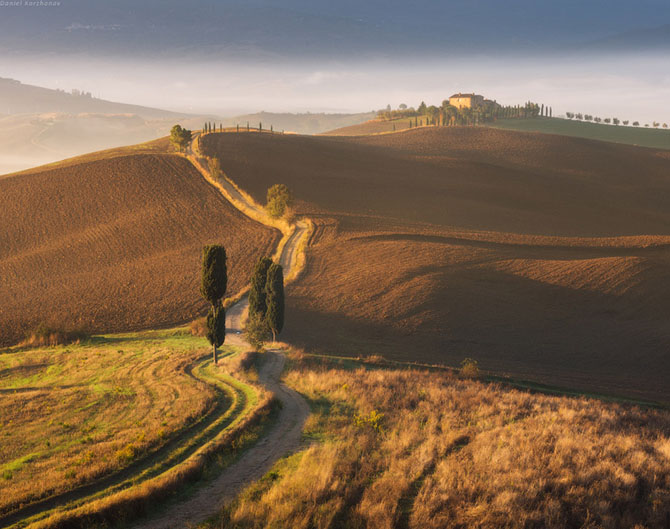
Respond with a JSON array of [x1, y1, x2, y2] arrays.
[[0, 328, 267, 526]]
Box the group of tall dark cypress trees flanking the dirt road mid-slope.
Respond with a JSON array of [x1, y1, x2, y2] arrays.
[[200, 244, 284, 364]]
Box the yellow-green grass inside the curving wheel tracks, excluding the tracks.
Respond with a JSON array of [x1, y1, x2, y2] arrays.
[[0, 334, 215, 514]]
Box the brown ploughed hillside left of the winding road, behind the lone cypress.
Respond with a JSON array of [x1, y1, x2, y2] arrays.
[[0, 151, 279, 344]]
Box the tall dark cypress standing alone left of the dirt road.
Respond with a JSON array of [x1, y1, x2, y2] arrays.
[[200, 244, 228, 364]]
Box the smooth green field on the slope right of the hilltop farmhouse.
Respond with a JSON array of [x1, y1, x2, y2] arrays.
[[488, 118, 670, 149]]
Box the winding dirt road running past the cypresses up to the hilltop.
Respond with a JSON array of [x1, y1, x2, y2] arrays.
[[135, 132, 316, 529]]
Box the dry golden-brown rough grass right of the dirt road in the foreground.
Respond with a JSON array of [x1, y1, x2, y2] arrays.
[[209, 356, 670, 529]]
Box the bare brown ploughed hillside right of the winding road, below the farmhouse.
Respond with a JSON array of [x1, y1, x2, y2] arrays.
[[203, 128, 670, 402]]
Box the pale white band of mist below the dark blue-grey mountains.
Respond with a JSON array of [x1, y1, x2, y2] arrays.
[[0, 53, 670, 122]]
